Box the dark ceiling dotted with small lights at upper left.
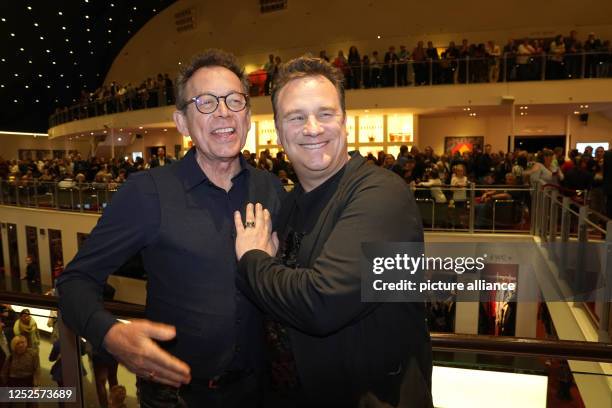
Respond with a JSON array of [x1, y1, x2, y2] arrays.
[[0, 0, 176, 132]]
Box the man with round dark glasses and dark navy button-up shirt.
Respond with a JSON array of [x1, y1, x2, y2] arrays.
[[58, 50, 282, 408]]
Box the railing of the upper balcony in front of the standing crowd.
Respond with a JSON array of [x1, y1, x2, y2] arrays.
[[49, 51, 612, 127]]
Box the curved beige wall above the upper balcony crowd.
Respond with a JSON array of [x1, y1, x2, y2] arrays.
[[106, 0, 612, 83]]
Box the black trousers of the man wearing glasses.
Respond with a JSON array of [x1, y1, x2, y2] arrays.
[[137, 374, 263, 408]]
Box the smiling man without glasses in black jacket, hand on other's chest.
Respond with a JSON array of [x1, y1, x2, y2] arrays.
[[234, 57, 431, 407]]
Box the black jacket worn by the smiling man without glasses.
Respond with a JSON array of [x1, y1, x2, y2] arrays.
[[238, 154, 431, 407]]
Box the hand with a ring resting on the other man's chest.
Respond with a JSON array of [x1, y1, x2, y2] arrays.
[[234, 203, 278, 260]]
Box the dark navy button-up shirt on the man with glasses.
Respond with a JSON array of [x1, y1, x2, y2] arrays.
[[58, 149, 282, 379]]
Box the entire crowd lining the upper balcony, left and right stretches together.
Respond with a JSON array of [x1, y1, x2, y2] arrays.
[[50, 30, 612, 126]]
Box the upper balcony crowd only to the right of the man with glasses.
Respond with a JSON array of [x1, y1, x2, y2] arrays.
[[263, 30, 612, 95]]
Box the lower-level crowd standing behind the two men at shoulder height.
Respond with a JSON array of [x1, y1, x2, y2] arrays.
[[0, 144, 606, 214]]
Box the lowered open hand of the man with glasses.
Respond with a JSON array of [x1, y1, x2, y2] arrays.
[[104, 320, 191, 388]]
